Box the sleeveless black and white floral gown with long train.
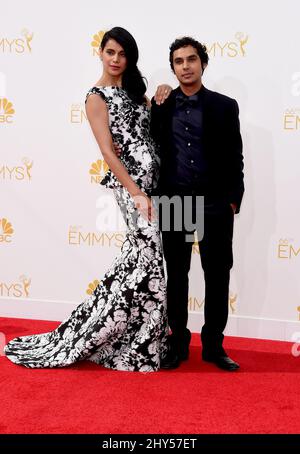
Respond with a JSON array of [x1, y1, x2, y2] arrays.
[[5, 87, 167, 372]]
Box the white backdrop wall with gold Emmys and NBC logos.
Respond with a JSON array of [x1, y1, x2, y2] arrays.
[[0, 0, 300, 340]]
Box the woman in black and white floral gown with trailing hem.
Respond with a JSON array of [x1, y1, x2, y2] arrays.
[[5, 27, 167, 372]]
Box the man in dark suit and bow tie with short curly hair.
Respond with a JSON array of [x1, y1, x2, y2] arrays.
[[151, 37, 244, 371]]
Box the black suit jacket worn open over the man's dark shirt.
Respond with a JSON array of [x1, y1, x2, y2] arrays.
[[151, 86, 244, 213]]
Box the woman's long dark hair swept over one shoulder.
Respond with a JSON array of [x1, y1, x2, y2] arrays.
[[101, 27, 147, 104]]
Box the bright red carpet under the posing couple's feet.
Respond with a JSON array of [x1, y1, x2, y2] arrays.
[[0, 318, 300, 434]]
